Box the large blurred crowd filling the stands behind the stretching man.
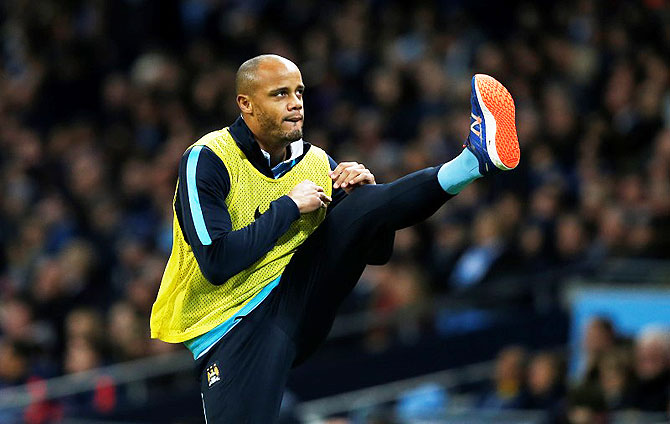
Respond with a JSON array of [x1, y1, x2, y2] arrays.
[[0, 0, 670, 420]]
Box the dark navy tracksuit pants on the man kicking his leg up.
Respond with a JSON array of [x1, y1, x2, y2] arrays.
[[196, 167, 451, 424]]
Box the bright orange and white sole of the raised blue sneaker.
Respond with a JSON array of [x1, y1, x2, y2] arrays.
[[475, 74, 521, 170]]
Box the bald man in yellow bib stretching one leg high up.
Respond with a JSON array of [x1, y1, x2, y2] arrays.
[[151, 55, 519, 424]]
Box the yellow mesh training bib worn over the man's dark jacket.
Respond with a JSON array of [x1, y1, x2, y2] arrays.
[[151, 128, 332, 343]]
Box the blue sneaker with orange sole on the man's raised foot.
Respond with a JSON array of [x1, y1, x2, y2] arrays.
[[465, 74, 521, 175]]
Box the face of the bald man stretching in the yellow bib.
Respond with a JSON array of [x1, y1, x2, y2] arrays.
[[251, 61, 305, 143]]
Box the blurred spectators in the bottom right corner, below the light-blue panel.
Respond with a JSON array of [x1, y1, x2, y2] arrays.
[[470, 317, 670, 424]]
